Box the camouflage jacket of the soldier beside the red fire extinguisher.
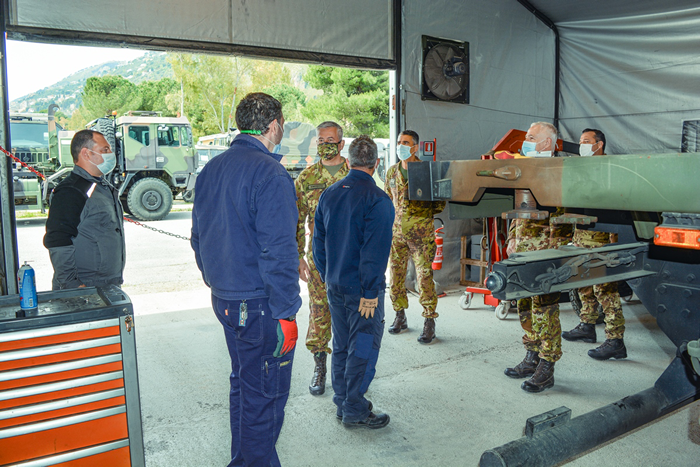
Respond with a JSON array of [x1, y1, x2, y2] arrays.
[[384, 162, 445, 234]]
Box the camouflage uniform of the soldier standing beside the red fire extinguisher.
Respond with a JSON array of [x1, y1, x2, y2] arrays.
[[384, 162, 445, 318]]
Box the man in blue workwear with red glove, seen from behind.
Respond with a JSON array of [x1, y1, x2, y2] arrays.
[[192, 93, 301, 466]]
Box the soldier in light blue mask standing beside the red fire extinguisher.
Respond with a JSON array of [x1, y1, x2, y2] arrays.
[[384, 130, 445, 344]]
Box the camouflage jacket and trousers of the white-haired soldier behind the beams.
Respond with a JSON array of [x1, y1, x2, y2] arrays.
[[510, 208, 573, 362]]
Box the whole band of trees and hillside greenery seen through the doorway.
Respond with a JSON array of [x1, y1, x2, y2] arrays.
[[13, 52, 389, 139]]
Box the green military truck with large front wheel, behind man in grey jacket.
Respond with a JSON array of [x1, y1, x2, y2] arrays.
[[87, 111, 198, 221]]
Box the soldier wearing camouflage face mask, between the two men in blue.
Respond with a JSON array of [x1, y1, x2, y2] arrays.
[[294, 122, 350, 396]]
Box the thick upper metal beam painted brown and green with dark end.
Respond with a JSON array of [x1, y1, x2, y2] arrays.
[[408, 153, 700, 215]]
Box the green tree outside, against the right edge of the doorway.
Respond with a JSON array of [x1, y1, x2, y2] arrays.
[[302, 65, 389, 138]]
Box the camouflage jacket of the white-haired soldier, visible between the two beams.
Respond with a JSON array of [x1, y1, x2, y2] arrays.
[[508, 208, 574, 253]]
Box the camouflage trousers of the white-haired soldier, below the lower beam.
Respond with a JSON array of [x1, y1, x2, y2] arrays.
[[518, 292, 561, 362]]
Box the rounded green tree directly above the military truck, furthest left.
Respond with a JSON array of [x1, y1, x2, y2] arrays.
[[81, 75, 141, 121]]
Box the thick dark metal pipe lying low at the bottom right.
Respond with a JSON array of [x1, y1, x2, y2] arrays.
[[479, 387, 668, 467]]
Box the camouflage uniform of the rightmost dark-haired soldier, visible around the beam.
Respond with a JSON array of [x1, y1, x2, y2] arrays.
[[573, 229, 625, 339]]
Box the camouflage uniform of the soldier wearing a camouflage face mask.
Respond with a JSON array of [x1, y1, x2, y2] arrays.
[[294, 159, 350, 354]]
